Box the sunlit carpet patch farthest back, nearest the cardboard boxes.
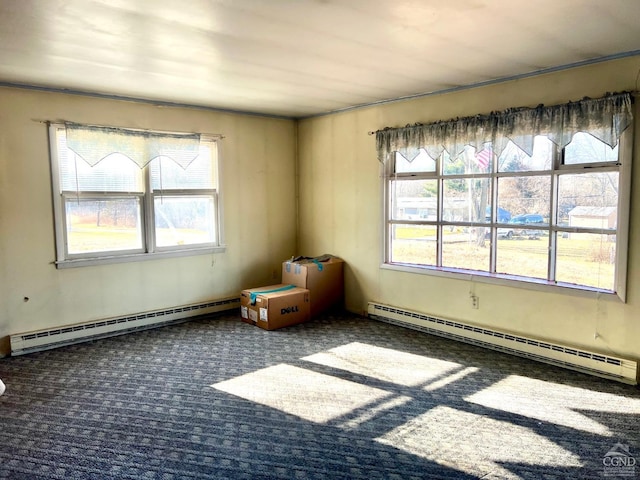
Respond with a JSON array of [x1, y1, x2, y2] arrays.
[[303, 342, 462, 387]]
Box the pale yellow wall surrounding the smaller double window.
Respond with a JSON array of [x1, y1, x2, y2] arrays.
[[0, 88, 296, 354]]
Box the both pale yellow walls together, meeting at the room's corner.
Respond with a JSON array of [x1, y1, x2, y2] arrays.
[[0, 57, 640, 364]]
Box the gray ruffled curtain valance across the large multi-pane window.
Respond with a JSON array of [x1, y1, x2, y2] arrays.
[[375, 93, 633, 165]]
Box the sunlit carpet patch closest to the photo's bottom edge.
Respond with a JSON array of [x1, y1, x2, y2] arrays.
[[376, 406, 582, 478]]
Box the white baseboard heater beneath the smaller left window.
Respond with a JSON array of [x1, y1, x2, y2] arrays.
[[10, 297, 240, 355]]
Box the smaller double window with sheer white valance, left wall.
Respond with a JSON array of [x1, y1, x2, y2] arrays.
[[50, 124, 221, 267]]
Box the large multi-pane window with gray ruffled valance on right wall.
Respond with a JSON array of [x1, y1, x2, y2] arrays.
[[377, 92, 632, 298]]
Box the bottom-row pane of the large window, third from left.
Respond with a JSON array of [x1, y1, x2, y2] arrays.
[[496, 231, 549, 280]]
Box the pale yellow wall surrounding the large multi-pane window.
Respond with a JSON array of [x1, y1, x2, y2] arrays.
[[299, 57, 640, 358]]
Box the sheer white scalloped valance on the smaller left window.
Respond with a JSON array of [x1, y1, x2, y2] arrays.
[[65, 123, 200, 168]]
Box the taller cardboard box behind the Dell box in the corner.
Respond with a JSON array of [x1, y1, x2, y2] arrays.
[[282, 255, 344, 317]]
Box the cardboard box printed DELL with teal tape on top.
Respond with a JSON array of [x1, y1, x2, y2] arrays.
[[240, 284, 310, 330]]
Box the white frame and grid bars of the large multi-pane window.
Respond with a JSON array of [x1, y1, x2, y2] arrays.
[[380, 122, 635, 302]]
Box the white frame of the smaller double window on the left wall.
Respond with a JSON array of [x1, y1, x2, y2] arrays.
[[49, 122, 226, 269]]
